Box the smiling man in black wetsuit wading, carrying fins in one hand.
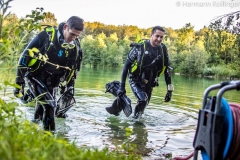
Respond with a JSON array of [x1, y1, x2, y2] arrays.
[[117, 26, 173, 119]]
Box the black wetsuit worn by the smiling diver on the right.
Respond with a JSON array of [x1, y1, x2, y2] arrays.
[[121, 41, 171, 117]]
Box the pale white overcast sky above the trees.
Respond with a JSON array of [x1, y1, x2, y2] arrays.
[[8, 0, 240, 30]]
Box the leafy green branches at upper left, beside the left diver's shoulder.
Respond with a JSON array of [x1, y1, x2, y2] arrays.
[[0, 0, 45, 67]]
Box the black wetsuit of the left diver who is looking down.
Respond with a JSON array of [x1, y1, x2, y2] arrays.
[[17, 23, 82, 130]]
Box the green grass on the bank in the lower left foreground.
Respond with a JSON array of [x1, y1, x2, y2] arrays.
[[0, 98, 141, 160]]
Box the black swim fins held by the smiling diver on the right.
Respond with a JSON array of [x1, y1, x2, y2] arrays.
[[106, 81, 132, 117]]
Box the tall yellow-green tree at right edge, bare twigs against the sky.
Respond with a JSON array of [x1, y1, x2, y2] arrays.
[[205, 11, 240, 64]]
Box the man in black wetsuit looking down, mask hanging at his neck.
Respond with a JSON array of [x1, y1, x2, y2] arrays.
[[14, 16, 84, 130]]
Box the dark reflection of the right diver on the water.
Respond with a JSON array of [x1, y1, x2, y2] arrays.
[[106, 117, 152, 155]]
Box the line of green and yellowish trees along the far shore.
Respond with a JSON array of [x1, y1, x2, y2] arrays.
[[0, 0, 240, 77]]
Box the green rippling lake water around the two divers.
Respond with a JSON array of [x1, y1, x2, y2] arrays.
[[2, 68, 240, 159]]
